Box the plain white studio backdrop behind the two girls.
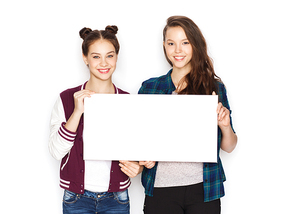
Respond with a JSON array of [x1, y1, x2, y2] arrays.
[[0, 0, 296, 214]]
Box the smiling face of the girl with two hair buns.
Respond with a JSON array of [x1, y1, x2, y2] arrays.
[[83, 39, 117, 81]]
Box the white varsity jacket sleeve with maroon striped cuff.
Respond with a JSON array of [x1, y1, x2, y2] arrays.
[[48, 97, 76, 160]]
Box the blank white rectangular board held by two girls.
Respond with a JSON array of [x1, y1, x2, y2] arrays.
[[83, 94, 218, 162]]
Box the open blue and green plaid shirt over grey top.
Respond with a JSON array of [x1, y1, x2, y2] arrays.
[[139, 69, 236, 202]]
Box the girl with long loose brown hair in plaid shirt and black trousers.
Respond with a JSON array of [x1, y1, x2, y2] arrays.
[[139, 16, 237, 214]]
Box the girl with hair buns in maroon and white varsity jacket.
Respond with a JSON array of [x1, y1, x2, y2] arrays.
[[49, 26, 143, 214]]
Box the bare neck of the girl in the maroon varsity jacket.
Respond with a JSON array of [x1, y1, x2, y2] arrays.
[[85, 78, 115, 94]]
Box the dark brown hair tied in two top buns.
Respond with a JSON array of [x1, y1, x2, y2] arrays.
[[79, 25, 120, 56]]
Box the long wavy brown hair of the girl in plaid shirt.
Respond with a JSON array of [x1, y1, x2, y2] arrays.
[[163, 16, 221, 95]]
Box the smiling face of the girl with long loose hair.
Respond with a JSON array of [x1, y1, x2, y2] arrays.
[[163, 26, 192, 73]]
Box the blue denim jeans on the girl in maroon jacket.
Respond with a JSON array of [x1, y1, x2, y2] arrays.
[[63, 190, 130, 214]]
